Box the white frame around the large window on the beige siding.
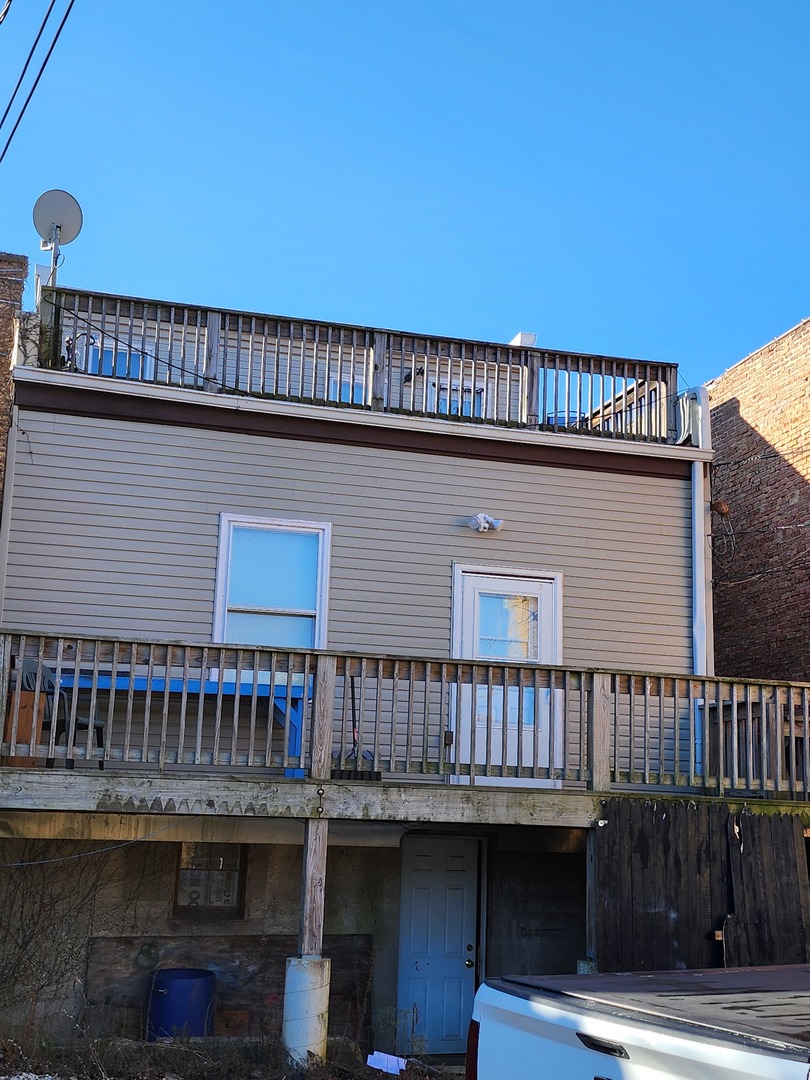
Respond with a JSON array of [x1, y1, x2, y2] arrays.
[[212, 513, 332, 649]]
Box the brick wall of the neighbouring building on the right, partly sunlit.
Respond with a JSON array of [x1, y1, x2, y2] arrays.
[[708, 320, 810, 681]]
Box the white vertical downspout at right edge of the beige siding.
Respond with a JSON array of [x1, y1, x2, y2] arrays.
[[688, 387, 714, 675]]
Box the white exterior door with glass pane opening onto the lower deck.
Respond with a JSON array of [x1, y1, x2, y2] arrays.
[[450, 567, 564, 787]]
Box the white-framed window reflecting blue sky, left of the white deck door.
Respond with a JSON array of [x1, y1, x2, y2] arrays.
[[214, 514, 330, 649]]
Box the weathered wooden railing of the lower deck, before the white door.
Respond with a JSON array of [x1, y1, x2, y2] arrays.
[[0, 633, 810, 799]]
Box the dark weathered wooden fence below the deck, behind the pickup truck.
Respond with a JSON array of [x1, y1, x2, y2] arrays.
[[594, 798, 810, 971]]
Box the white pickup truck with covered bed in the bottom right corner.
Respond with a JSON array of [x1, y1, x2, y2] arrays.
[[467, 964, 810, 1080]]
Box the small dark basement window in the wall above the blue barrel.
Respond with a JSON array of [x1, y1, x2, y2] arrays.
[[174, 843, 247, 919]]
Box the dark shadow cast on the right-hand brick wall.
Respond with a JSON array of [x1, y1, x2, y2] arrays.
[[712, 397, 810, 681]]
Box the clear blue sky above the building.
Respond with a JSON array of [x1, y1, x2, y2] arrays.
[[0, 0, 810, 384]]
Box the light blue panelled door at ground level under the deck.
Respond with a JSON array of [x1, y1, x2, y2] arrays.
[[397, 837, 478, 1054]]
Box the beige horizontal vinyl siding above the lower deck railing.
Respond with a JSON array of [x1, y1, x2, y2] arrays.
[[3, 411, 691, 672]]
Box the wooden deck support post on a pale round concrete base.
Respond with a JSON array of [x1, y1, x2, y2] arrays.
[[282, 656, 336, 1065]]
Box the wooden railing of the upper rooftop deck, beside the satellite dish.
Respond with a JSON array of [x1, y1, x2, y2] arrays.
[[39, 288, 677, 443]]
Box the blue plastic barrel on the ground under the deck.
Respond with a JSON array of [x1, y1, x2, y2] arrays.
[[146, 968, 217, 1042]]
